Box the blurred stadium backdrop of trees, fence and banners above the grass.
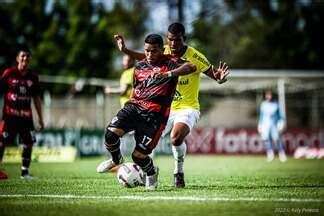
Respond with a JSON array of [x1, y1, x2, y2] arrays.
[[0, 0, 324, 159]]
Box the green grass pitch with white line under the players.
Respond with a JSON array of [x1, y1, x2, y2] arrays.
[[0, 155, 324, 216]]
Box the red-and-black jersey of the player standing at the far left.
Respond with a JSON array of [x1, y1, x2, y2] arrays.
[[0, 67, 40, 119]]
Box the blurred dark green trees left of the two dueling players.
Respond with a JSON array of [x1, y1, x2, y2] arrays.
[[0, 0, 147, 92]]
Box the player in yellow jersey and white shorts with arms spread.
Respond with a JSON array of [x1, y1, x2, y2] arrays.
[[115, 23, 229, 188]]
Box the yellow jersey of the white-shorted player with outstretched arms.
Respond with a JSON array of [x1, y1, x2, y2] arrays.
[[164, 45, 211, 111]]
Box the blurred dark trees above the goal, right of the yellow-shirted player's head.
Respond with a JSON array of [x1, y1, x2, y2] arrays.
[[193, 0, 324, 69]]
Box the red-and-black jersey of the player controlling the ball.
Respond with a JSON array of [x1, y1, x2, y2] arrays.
[[129, 55, 185, 115]]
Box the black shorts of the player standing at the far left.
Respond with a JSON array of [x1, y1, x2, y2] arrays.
[[0, 118, 36, 146]]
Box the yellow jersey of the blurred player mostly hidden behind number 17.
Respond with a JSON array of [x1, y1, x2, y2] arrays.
[[119, 67, 134, 107]]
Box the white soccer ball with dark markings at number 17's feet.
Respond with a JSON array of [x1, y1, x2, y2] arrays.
[[117, 163, 144, 188]]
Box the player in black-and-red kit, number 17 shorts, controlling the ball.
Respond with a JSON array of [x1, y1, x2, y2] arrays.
[[97, 34, 196, 190]]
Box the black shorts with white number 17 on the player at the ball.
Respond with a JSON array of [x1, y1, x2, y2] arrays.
[[108, 103, 168, 155]]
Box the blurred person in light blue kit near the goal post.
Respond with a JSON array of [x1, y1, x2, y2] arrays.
[[258, 90, 287, 162]]
